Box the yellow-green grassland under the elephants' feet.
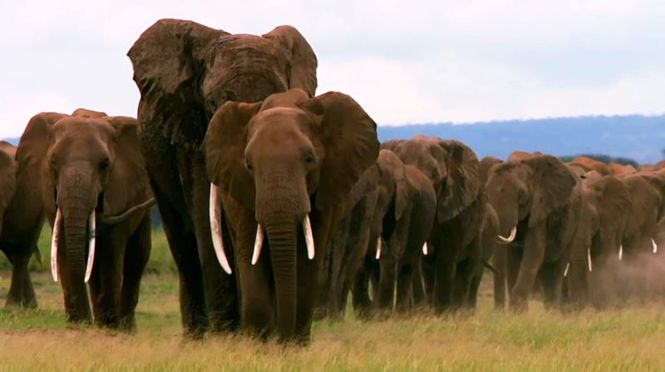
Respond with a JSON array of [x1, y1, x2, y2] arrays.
[[0, 232, 665, 371]]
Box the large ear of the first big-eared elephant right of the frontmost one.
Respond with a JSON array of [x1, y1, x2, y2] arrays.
[[437, 140, 481, 222]]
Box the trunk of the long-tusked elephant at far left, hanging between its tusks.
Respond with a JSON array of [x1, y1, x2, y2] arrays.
[[58, 168, 94, 322]]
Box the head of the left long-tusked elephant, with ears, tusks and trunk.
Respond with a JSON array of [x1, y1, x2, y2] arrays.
[[16, 110, 154, 321]]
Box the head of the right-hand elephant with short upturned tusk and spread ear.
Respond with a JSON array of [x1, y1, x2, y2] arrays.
[[485, 154, 577, 240]]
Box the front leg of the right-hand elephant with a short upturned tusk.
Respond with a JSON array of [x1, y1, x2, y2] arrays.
[[510, 224, 546, 311]]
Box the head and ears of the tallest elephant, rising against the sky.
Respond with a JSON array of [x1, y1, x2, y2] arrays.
[[128, 19, 317, 148]]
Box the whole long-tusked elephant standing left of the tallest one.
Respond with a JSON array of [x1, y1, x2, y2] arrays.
[[16, 110, 154, 330]]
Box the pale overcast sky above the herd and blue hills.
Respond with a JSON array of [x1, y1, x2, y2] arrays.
[[0, 0, 665, 137]]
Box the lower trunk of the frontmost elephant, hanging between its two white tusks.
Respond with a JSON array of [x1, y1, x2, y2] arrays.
[[266, 221, 298, 341]]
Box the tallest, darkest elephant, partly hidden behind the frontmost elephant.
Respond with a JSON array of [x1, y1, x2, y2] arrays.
[[128, 19, 317, 338]]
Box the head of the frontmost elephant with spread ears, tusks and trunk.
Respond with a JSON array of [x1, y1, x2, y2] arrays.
[[204, 89, 379, 338]]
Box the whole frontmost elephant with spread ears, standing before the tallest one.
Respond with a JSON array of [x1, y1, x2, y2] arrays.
[[203, 89, 379, 344]]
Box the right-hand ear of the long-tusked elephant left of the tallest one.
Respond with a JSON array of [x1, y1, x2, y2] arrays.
[[104, 116, 152, 216]]
